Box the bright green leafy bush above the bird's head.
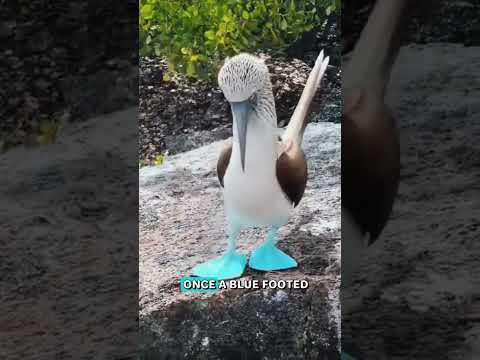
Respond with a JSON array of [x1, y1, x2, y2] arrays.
[[139, 0, 340, 77]]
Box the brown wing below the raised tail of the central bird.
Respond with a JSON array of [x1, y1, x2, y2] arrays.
[[277, 142, 308, 206]]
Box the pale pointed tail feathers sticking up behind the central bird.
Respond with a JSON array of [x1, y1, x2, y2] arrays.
[[282, 50, 330, 144]]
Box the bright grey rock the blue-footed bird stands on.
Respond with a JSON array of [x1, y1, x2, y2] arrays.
[[139, 123, 340, 360]]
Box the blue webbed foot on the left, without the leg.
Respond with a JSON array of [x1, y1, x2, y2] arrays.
[[192, 251, 247, 280]]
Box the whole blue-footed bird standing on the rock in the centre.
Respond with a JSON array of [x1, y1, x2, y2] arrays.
[[192, 50, 329, 279]]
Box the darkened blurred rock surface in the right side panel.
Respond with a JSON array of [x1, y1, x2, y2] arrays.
[[342, 44, 480, 360]]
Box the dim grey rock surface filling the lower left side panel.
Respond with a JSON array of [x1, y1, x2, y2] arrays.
[[0, 109, 138, 360]]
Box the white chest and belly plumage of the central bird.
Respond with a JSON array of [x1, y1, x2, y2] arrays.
[[224, 118, 293, 226]]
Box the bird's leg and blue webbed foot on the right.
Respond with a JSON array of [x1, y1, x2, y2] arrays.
[[248, 226, 297, 271]]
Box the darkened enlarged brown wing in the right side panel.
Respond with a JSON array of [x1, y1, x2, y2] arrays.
[[341, 91, 400, 243]]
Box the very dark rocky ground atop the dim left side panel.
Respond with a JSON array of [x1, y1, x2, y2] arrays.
[[0, 0, 138, 151]]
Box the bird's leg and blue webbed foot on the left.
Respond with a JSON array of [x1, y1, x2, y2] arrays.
[[192, 219, 247, 280]]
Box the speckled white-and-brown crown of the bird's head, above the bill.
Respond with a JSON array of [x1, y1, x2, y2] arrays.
[[218, 54, 269, 102]]
